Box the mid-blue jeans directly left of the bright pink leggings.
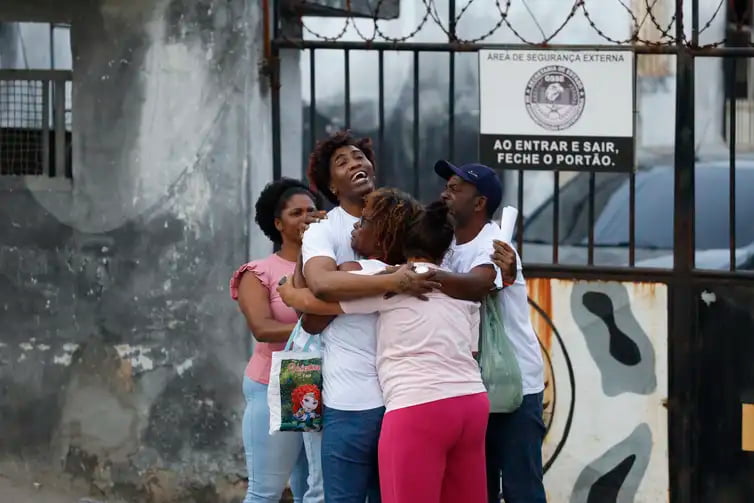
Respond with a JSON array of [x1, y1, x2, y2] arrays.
[[322, 407, 385, 503]]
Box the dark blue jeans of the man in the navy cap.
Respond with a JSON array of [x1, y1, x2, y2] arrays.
[[486, 393, 547, 503]]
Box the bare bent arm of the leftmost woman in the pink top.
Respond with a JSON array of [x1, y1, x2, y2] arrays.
[[238, 274, 295, 342]]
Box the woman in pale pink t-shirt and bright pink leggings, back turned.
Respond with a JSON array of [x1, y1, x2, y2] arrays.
[[281, 202, 489, 503]]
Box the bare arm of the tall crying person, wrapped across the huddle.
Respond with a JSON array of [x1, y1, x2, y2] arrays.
[[304, 257, 440, 301]]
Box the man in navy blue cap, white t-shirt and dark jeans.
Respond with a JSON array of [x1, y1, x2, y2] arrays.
[[435, 161, 546, 503]]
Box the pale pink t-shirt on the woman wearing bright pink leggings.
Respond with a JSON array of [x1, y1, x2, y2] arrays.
[[340, 264, 485, 411]]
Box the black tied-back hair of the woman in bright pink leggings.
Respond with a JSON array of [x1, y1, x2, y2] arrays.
[[403, 201, 454, 263]]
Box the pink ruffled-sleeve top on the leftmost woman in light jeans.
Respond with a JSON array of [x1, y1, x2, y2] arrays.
[[230, 253, 298, 384]]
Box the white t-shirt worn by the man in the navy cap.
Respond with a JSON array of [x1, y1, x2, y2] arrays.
[[443, 222, 545, 395]]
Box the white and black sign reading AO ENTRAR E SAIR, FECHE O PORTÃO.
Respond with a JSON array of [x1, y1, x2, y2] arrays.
[[479, 50, 634, 171]]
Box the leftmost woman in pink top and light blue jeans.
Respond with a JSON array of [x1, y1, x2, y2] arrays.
[[230, 178, 324, 503]]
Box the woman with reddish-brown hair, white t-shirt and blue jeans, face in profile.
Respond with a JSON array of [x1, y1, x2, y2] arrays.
[[302, 188, 422, 503]]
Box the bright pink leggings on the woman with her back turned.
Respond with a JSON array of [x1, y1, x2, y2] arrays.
[[379, 393, 490, 503]]
